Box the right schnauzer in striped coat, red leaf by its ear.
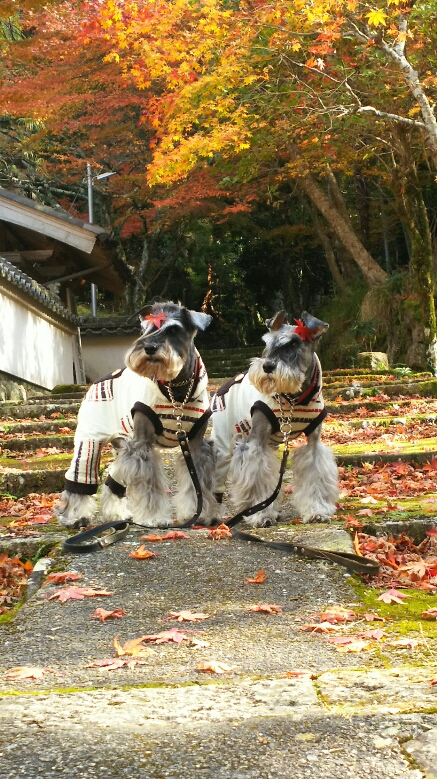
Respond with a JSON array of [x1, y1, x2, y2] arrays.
[[211, 311, 338, 527]]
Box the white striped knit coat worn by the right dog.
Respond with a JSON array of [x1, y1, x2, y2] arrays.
[[211, 354, 327, 493]]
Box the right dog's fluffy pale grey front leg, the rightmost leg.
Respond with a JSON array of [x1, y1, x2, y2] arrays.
[[291, 425, 339, 522]]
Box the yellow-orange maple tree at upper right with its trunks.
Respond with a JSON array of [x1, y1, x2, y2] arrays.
[[91, 0, 437, 370]]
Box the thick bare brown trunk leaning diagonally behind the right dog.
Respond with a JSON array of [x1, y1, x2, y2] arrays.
[[297, 172, 387, 286]]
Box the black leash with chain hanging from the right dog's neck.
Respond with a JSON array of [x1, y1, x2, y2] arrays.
[[226, 395, 379, 576]]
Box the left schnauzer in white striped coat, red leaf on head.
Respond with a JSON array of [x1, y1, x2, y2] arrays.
[[56, 302, 218, 527]]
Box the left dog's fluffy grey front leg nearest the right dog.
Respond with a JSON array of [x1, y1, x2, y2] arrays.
[[174, 432, 221, 527]]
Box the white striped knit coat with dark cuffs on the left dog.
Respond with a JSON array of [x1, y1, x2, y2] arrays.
[[65, 350, 212, 495]]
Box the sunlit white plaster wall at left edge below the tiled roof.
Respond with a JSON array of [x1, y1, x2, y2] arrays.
[[0, 289, 73, 389]]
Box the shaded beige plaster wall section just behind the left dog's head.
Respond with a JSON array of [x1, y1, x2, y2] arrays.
[[82, 335, 136, 381]]
